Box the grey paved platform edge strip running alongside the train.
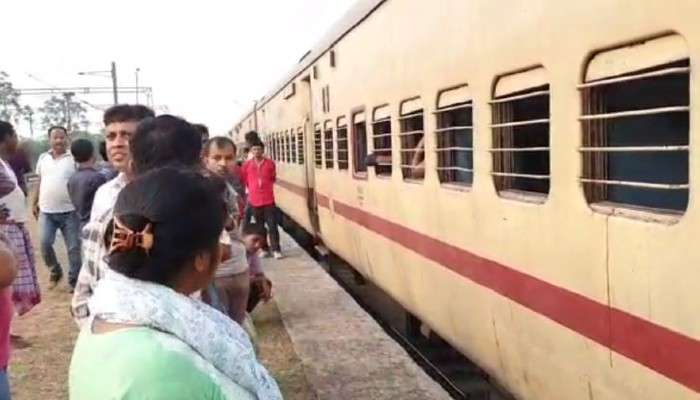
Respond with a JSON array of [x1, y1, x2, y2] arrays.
[[264, 231, 451, 400]]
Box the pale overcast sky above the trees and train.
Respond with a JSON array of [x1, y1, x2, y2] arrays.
[[0, 0, 355, 136]]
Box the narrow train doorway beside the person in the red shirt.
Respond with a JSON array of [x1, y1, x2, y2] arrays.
[[299, 75, 321, 240]]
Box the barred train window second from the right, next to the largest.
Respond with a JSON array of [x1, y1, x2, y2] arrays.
[[491, 67, 550, 201]]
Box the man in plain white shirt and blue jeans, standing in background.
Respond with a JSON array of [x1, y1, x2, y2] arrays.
[[34, 126, 81, 289]]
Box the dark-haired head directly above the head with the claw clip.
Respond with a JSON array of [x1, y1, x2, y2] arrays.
[[129, 115, 202, 175]]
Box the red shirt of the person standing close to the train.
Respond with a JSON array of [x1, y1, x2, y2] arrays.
[[241, 158, 277, 207]]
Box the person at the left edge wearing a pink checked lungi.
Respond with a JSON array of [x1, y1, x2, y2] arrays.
[[0, 121, 41, 314]]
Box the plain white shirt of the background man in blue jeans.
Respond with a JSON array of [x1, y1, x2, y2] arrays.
[[36, 151, 76, 214]]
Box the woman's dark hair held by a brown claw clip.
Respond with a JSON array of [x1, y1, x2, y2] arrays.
[[104, 167, 225, 285]]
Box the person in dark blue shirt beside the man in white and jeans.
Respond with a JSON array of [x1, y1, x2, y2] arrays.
[[68, 139, 107, 232]]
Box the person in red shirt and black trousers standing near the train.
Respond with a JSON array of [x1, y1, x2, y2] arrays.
[[241, 139, 282, 259]]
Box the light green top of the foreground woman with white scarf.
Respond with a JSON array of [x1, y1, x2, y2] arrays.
[[68, 326, 254, 400]]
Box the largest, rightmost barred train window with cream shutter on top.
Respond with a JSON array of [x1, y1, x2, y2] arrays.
[[579, 35, 690, 214]]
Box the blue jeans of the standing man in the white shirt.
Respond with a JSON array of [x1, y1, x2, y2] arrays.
[[39, 211, 81, 287]]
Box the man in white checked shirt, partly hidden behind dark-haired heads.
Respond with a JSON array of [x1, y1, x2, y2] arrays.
[[71, 104, 155, 323]]
